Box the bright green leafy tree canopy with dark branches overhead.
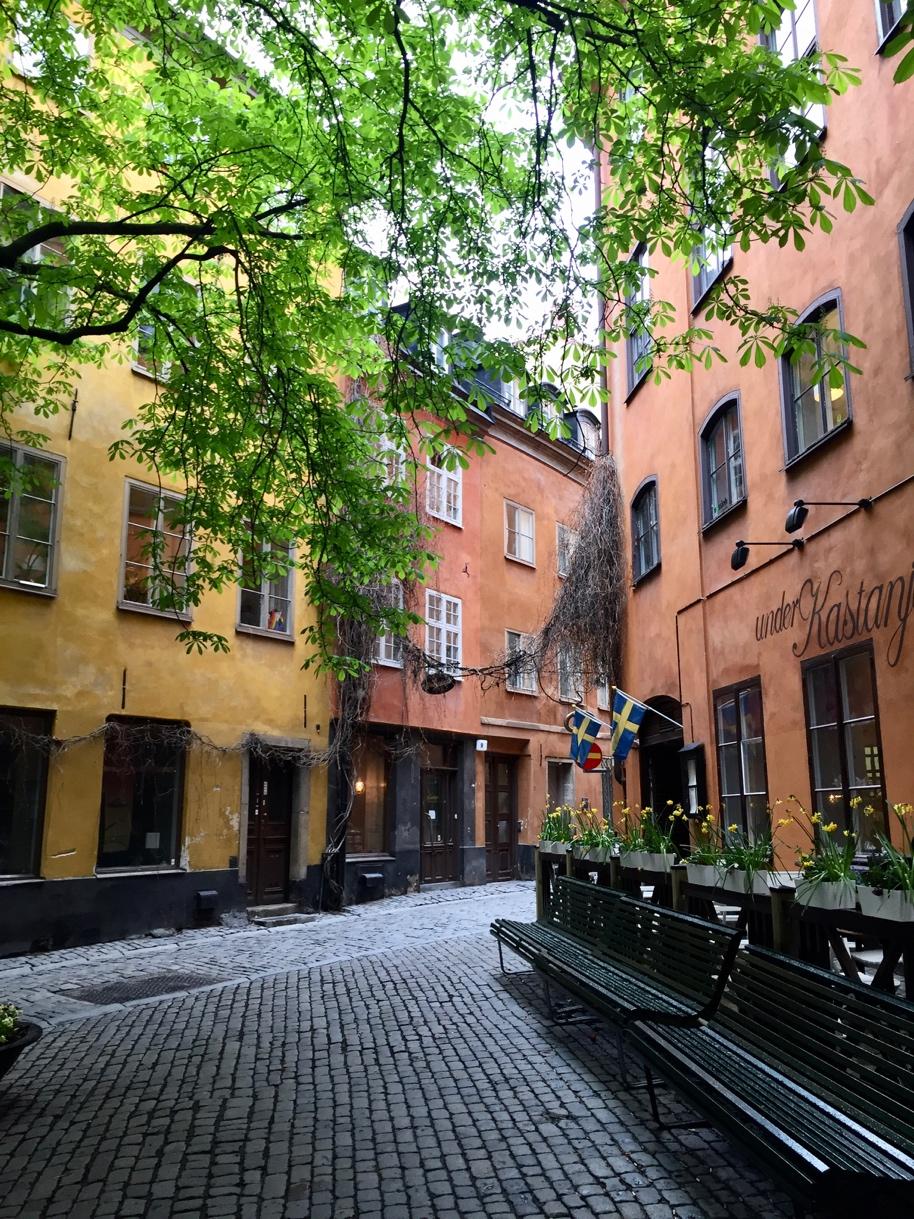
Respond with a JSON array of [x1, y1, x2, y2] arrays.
[[0, 0, 892, 674]]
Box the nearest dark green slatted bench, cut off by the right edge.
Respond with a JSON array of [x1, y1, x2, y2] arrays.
[[630, 947, 914, 1219]]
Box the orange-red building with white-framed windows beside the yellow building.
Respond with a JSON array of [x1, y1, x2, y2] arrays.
[[328, 388, 606, 901]]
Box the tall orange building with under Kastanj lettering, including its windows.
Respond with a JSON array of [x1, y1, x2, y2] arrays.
[[608, 0, 914, 865]]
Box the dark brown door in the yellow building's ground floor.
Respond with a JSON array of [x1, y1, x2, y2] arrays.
[[247, 757, 295, 906]]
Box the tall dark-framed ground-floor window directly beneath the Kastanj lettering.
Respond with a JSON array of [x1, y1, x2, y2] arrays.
[[803, 644, 887, 851]]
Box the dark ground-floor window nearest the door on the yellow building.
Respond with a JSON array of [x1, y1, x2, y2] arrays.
[[99, 719, 188, 868]]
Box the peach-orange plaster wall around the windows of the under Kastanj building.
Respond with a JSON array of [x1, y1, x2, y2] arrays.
[[609, 0, 914, 858]]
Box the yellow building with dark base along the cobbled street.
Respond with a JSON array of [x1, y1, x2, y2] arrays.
[[0, 176, 329, 953]]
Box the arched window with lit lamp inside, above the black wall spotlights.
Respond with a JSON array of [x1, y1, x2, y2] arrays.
[[782, 300, 849, 461]]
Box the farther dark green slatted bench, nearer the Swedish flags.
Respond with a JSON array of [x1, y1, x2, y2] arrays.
[[491, 876, 742, 1080]]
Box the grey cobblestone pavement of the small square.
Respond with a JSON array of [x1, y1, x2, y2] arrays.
[[0, 884, 790, 1219]]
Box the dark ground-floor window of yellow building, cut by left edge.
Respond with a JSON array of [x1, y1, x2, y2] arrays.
[[0, 707, 52, 876]]
